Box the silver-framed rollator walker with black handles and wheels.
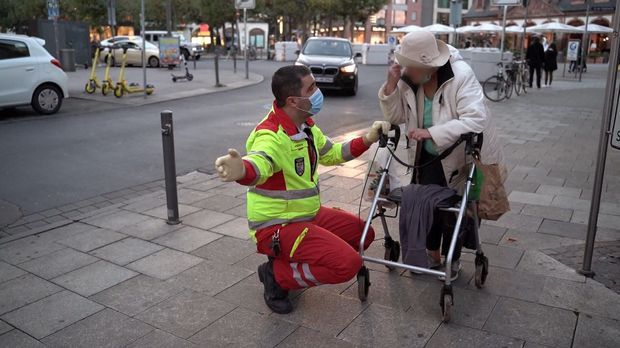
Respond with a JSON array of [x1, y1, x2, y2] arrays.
[[357, 125, 489, 322]]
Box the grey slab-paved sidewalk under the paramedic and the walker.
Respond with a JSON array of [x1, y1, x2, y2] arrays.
[[0, 66, 620, 348]]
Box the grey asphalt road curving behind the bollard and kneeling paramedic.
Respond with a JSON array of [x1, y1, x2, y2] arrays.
[[0, 61, 386, 214]]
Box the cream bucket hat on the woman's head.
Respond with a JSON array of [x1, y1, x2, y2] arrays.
[[394, 30, 450, 68]]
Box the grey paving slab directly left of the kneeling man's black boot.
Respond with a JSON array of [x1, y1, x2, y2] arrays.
[[168, 260, 252, 295]]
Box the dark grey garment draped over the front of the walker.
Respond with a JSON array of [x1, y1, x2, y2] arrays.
[[399, 184, 457, 268]]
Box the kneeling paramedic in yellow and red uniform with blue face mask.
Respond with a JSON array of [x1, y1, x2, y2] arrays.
[[215, 66, 390, 314]]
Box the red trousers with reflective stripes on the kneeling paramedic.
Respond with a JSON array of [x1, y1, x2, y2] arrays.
[[256, 207, 375, 290]]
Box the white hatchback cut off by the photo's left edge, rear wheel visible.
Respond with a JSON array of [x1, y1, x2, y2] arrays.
[[0, 34, 69, 115]]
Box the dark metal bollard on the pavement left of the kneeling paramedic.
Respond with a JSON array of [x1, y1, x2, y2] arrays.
[[161, 110, 181, 225]]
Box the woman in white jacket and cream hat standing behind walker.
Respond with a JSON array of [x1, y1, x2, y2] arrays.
[[379, 31, 503, 279]]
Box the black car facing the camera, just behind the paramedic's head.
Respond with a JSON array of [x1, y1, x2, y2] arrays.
[[295, 37, 361, 95]]
